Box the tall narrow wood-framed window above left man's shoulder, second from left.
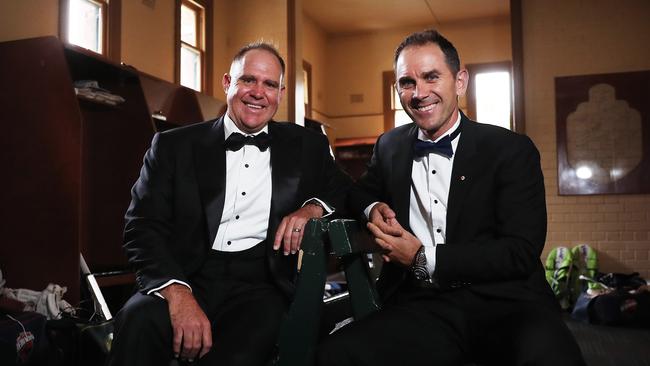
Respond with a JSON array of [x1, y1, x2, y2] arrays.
[[176, 0, 211, 91]]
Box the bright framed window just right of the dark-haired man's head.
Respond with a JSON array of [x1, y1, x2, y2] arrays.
[[467, 62, 512, 129]]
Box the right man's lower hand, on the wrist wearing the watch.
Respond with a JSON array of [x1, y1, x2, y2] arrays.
[[367, 217, 422, 266]]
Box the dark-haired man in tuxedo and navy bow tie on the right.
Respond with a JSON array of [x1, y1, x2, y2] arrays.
[[318, 30, 584, 366]]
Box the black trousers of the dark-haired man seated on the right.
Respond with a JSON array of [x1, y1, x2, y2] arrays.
[[317, 289, 585, 366]]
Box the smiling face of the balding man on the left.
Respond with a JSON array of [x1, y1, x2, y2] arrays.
[[223, 49, 284, 133]]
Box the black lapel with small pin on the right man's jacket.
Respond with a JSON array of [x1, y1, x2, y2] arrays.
[[447, 113, 478, 241]]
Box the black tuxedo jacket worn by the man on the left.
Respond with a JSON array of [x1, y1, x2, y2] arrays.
[[124, 118, 349, 295]]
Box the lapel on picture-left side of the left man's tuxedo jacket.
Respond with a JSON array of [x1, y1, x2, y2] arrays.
[[194, 117, 226, 245]]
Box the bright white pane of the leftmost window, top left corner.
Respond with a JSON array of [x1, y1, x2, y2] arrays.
[[68, 0, 102, 53]]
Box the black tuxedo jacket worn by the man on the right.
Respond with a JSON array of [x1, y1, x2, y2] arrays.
[[351, 113, 554, 303]]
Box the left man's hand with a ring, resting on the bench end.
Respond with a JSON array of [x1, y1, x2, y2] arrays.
[[273, 203, 323, 255]]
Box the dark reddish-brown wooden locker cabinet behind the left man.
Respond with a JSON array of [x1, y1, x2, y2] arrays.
[[0, 37, 223, 304]]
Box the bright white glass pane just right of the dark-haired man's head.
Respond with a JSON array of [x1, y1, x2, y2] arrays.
[[476, 71, 511, 129]]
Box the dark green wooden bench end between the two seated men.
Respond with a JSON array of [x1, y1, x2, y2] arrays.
[[274, 219, 380, 366]]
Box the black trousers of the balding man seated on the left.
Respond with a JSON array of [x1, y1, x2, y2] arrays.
[[108, 243, 287, 366]]
